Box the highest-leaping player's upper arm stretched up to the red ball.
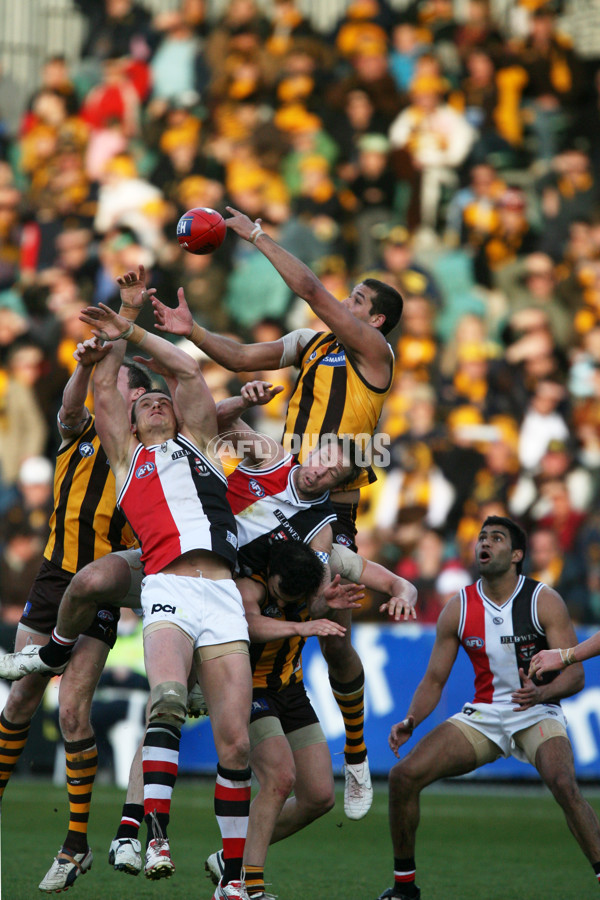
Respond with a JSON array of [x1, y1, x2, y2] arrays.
[[225, 206, 391, 387]]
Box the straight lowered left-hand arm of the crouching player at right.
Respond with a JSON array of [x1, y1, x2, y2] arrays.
[[388, 594, 460, 756]]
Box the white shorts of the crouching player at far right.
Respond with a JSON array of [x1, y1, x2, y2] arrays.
[[450, 703, 567, 763]]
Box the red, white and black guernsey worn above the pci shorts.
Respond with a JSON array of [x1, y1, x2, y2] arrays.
[[117, 434, 237, 575]]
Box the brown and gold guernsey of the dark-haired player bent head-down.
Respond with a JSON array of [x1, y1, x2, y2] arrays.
[[250, 578, 310, 691]]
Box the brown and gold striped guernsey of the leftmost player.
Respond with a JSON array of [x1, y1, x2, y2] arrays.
[[44, 416, 136, 572]]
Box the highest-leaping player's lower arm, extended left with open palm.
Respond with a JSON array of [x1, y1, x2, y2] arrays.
[[152, 288, 284, 372]]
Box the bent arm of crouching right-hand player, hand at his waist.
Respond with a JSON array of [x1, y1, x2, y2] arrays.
[[512, 587, 585, 709]]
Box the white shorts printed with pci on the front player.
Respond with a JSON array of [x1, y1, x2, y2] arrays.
[[142, 572, 249, 649]]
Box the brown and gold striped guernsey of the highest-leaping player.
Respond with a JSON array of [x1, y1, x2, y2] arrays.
[[283, 332, 393, 490]]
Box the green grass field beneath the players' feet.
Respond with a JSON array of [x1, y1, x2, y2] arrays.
[[1, 778, 600, 900]]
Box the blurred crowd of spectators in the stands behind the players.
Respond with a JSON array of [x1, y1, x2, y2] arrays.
[[0, 0, 600, 640]]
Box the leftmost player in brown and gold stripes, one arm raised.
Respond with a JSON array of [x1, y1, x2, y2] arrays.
[[0, 292, 151, 892]]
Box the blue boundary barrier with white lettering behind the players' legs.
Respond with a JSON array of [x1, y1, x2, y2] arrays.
[[179, 624, 600, 780]]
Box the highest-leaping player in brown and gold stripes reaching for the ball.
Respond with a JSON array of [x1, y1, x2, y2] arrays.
[[153, 209, 403, 819]]
